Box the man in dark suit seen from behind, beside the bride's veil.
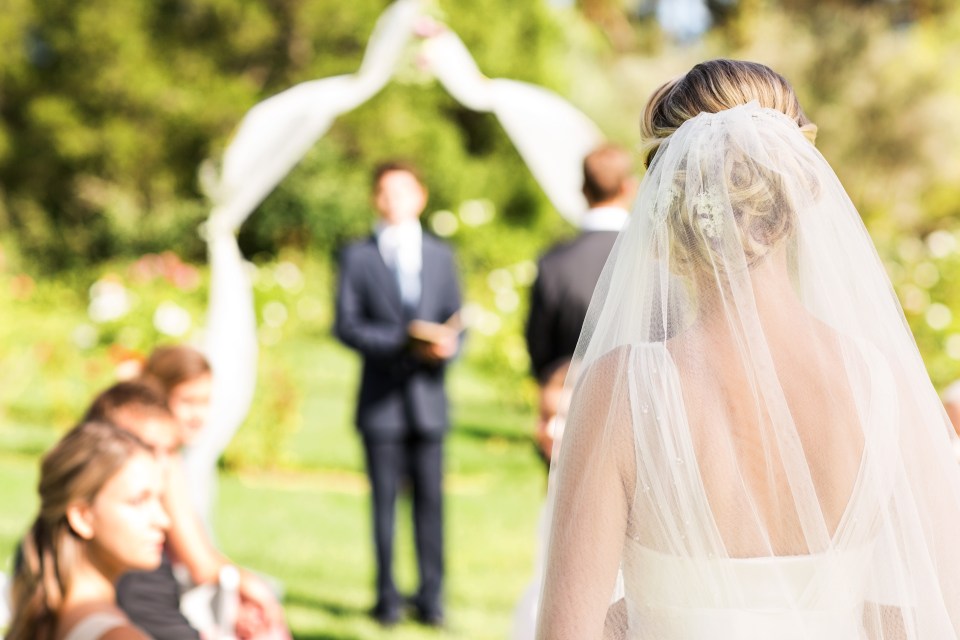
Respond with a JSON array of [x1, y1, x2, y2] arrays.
[[526, 144, 637, 461]]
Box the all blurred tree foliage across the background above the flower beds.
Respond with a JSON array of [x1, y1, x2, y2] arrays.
[[0, 0, 960, 390]]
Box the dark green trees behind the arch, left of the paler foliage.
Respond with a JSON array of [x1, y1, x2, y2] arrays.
[[0, 0, 562, 268]]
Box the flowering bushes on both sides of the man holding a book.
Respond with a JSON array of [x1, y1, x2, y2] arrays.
[[0, 218, 556, 466]]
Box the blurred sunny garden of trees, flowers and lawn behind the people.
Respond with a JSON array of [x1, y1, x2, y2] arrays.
[[0, 0, 960, 639]]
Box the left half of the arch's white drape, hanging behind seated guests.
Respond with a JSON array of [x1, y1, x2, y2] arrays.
[[184, 2, 418, 523]]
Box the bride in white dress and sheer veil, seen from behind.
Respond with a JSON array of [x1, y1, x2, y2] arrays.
[[538, 60, 960, 640]]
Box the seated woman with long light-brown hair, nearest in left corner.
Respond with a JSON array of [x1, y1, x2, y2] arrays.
[[7, 422, 169, 640]]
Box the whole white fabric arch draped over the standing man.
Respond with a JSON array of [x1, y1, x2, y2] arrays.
[[186, 0, 602, 517]]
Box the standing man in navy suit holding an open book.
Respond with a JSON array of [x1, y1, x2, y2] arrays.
[[334, 163, 460, 626]]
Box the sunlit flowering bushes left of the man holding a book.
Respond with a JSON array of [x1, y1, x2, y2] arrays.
[[0, 252, 320, 465]]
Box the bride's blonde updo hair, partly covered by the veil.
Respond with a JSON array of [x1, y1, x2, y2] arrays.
[[640, 59, 816, 275]]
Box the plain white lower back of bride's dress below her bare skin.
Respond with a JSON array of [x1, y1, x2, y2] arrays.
[[624, 543, 873, 640]]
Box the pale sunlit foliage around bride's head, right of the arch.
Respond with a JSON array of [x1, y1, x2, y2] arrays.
[[572, 0, 960, 385]]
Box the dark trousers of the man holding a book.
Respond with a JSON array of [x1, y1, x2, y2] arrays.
[[363, 435, 443, 614]]
